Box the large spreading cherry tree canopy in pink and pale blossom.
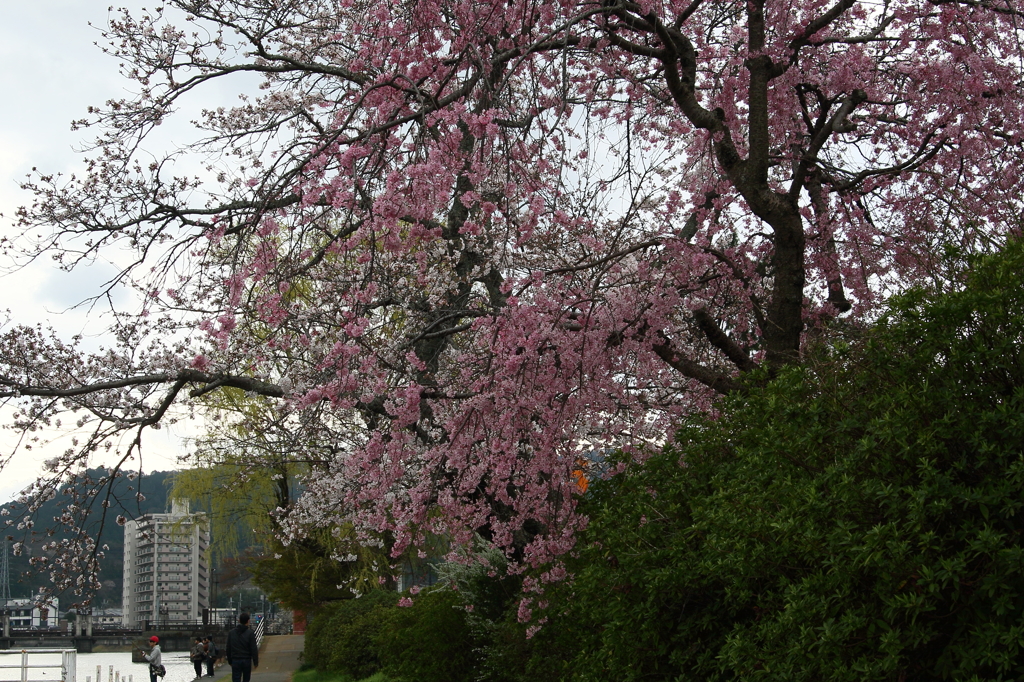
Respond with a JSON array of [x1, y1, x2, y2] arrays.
[[0, 0, 1024, 589]]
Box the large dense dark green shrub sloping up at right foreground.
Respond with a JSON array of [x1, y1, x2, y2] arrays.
[[549, 245, 1024, 682]]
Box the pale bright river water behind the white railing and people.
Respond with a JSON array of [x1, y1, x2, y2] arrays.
[[0, 649, 201, 682]]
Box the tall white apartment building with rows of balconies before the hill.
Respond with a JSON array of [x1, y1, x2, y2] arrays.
[[121, 503, 210, 628]]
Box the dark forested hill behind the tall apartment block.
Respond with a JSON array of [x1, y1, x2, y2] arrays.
[[2, 469, 175, 606]]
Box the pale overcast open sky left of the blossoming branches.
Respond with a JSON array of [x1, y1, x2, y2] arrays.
[[0, 0, 195, 502]]
